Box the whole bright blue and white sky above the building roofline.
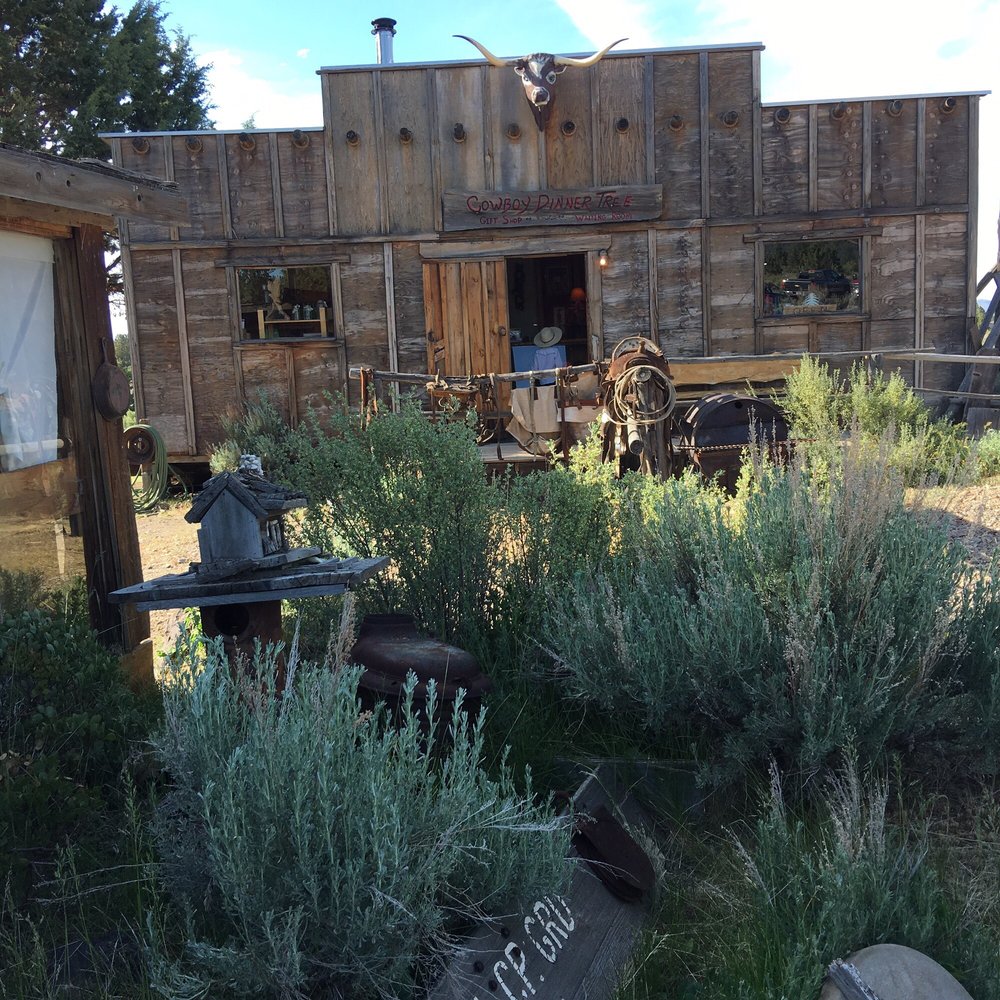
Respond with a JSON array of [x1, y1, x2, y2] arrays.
[[145, 0, 1000, 274]]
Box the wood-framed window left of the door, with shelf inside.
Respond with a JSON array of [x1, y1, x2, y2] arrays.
[[236, 264, 336, 340]]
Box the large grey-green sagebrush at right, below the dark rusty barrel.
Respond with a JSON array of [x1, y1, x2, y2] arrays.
[[543, 445, 1000, 786]]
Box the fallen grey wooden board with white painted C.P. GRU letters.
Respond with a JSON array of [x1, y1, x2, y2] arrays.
[[429, 769, 648, 1000]]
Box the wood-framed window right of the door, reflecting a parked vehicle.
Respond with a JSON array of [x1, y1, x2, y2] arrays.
[[761, 239, 861, 316]]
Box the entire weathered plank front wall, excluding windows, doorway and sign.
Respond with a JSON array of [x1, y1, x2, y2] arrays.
[[113, 46, 978, 456]]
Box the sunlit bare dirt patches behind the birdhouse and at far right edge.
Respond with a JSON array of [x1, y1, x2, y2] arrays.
[[136, 478, 1000, 653]]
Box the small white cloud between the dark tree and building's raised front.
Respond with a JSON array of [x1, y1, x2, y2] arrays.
[[198, 49, 323, 129]]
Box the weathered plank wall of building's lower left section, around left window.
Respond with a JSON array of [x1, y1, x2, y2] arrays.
[[113, 130, 364, 459]]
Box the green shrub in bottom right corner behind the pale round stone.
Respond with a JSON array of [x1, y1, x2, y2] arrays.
[[692, 770, 1000, 1000]]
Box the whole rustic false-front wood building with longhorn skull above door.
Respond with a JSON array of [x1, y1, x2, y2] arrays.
[[106, 44, 982, 463]]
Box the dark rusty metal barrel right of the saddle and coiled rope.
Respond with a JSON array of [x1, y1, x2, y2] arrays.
[[678, 392, 788, 493]]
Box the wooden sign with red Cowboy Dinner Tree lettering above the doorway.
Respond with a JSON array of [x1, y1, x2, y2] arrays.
[[442, 184, 663, 232]]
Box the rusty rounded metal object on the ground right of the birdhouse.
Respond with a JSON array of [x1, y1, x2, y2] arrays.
[[351, 614, 493, 718]]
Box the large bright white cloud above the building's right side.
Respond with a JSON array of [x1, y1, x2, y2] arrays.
[[557, 0, 1000, 274]]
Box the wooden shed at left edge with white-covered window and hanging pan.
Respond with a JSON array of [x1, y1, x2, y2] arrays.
[[0, 145, 187, 677]]
